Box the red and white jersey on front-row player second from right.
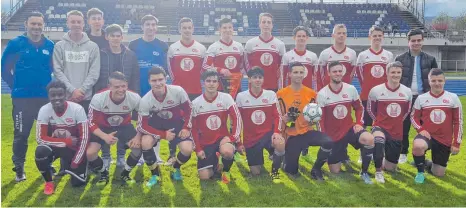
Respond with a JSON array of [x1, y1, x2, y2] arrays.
[[367, 83, 413, 140]]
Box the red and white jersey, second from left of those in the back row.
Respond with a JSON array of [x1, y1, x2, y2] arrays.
[[202, 40, 246, 74]]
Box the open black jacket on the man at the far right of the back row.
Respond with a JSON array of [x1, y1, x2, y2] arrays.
[[395, 50, 438, 92]]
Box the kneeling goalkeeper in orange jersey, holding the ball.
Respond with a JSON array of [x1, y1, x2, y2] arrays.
[[277, 62, 333, 180]]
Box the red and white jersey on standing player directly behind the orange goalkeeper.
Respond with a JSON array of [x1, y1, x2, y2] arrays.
[[282, 48, 319, 89]]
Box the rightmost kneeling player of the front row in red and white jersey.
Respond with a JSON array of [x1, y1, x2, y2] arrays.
[[411, 68, 463, 183]]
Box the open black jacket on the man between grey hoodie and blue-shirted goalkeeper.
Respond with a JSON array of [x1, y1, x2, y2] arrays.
[[94, 45, 140, 93]]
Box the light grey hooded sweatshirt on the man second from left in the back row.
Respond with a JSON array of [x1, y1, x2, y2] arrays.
[[53, 32, 100, 100]]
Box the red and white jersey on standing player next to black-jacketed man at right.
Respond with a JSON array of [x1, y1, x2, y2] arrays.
[[356, 48, 393, 101]]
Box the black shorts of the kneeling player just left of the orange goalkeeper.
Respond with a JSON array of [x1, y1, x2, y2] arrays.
[[246, 132, 273, 166]]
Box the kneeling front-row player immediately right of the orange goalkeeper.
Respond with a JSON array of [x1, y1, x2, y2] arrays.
[[317, 61, 374, 184]]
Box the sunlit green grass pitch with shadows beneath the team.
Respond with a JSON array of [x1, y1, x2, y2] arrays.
[[1, 95, 466, 207]]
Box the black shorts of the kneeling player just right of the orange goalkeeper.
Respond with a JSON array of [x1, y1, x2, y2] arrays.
[[328, 128, 366, 165]]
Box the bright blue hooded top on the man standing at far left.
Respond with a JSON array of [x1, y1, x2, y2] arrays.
[[2, 34, 54, 98]]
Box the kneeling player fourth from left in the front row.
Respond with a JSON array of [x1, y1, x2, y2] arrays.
[[191, 71, 244, 183]]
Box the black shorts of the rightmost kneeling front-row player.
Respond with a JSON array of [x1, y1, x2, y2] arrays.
[[414, 134, 451, 167]]
